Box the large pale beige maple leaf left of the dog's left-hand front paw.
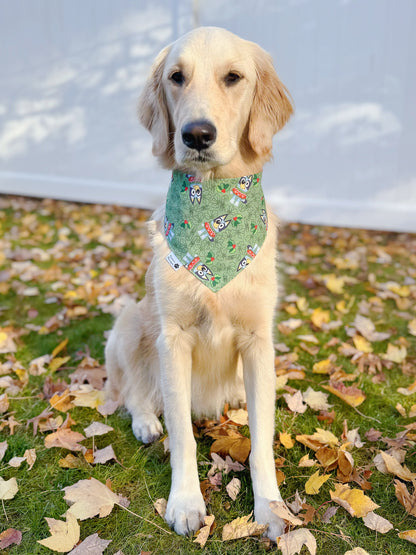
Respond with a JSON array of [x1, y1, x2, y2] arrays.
[[64, 478, 121, 520]]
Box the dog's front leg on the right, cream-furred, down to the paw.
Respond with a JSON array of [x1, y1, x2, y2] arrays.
[[241, 333, 285, 541]]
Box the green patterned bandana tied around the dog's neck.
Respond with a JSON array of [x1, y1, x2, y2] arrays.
[[164, 171, 267, 291]]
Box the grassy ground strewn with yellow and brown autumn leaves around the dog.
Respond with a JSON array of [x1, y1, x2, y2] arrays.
[[0, 196, 416, 555]]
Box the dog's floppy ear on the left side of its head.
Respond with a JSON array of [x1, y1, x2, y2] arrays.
[[138, 46, 171, 164]]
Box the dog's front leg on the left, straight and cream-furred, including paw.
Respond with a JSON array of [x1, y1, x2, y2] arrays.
[[158, 326, 206, 535]]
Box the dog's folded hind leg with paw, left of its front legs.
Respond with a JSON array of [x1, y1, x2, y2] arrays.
[[106, 297, 163, 443]]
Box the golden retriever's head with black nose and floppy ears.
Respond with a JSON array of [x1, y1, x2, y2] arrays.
[[139, 27, 293, 172]]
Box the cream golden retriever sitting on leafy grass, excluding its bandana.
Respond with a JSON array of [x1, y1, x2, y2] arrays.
[[106, 27, 292, 541]]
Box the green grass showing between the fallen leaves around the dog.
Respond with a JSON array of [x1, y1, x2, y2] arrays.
[[0, 197, 416, 555]]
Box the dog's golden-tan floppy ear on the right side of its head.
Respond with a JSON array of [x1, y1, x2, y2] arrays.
[[248, 43, 293, 156]]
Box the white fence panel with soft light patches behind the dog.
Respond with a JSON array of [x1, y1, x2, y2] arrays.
[[0, 0, 416, 231]]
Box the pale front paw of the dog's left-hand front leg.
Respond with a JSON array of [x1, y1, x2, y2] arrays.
[[165, 491, 206, 536]]
